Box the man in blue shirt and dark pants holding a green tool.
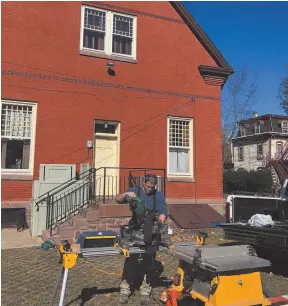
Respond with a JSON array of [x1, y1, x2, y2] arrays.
[[115, 174, 167, 305]]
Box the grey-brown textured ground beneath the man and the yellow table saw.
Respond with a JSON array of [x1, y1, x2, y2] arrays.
[[1, 231, 288, 306]]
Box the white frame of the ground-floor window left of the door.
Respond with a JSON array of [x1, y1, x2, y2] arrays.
[[1, 99, 37, 175]]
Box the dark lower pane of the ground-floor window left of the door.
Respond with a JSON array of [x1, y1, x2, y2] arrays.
[[1, 139, 30, 169]]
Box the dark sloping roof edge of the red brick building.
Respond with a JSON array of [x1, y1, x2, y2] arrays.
[[170, 1, 233, 75]]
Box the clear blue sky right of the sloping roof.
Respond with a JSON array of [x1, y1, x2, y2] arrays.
[[183, 1, 288, 115]]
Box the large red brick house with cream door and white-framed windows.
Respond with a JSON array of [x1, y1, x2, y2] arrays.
[[1, 1, 233, 234]]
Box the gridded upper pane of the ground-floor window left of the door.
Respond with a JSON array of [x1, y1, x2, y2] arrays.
[[1, 103, 32, 138]]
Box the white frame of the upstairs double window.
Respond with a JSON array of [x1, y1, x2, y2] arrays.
[[80, 5, 137, 60]]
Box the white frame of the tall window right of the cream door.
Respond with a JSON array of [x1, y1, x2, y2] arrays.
[[167, 116, 194, 178]]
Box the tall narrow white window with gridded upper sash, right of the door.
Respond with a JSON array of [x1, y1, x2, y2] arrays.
[[168, 118, 192, 176]]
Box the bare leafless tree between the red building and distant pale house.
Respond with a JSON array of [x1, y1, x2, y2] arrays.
[[222, 68, 258, 165]]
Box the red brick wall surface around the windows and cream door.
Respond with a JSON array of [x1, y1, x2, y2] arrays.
[[2, 2, 222, 204]]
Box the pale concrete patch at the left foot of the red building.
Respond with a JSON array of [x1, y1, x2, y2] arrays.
[[1, 228, 43, 250]]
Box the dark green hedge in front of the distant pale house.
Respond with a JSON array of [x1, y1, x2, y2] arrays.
[[223, 169, 273, 193]]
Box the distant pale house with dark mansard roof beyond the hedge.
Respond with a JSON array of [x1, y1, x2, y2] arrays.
[[232, 113, 288, 175]]
